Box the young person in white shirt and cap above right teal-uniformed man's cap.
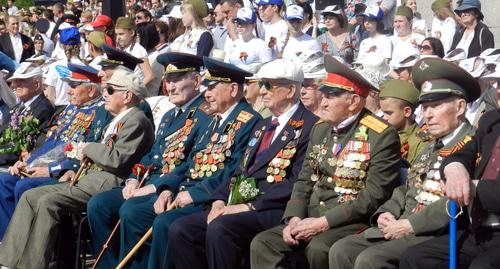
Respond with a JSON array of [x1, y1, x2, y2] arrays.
[[224, 7, 273, 70]]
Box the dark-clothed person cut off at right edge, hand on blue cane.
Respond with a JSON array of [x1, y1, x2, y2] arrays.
[[399, 51, 500, 269]]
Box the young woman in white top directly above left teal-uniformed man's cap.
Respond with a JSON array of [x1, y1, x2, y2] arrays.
[[170, 0, 214, 56]]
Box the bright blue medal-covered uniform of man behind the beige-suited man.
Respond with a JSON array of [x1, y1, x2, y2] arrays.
[[0, 62, 102, 237]]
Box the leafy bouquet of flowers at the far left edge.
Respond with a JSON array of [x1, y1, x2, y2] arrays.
[[0, 112, 40, 154]]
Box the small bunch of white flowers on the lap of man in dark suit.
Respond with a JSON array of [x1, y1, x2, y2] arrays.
[[228, 175, 262, 205]]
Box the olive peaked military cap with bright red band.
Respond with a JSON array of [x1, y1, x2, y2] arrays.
[[318, 55, 373, 97]]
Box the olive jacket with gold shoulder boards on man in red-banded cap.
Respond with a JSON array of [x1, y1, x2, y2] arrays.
[[283, 109, 402, 228]]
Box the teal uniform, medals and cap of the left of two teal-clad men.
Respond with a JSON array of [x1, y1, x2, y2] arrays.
[[87, 53, 211, 268]]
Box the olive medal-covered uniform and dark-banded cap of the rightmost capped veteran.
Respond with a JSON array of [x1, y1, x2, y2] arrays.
[[330, 56, 479, 268]]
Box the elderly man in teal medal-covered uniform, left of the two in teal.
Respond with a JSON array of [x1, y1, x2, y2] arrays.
[[87, 52, 210, 268]]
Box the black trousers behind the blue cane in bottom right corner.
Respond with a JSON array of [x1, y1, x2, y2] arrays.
[[399, 228, 500, 269]]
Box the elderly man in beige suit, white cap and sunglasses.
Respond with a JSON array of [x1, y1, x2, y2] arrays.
[[0, 66, 154, 268]]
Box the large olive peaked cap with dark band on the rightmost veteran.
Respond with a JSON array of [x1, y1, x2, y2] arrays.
[[411, 58, 481, 103]]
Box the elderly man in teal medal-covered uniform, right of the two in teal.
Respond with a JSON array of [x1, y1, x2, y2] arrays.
[[143, 57, 262, 268]]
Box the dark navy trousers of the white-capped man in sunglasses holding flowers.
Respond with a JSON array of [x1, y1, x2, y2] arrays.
[[167, 211, 265, 269]]
